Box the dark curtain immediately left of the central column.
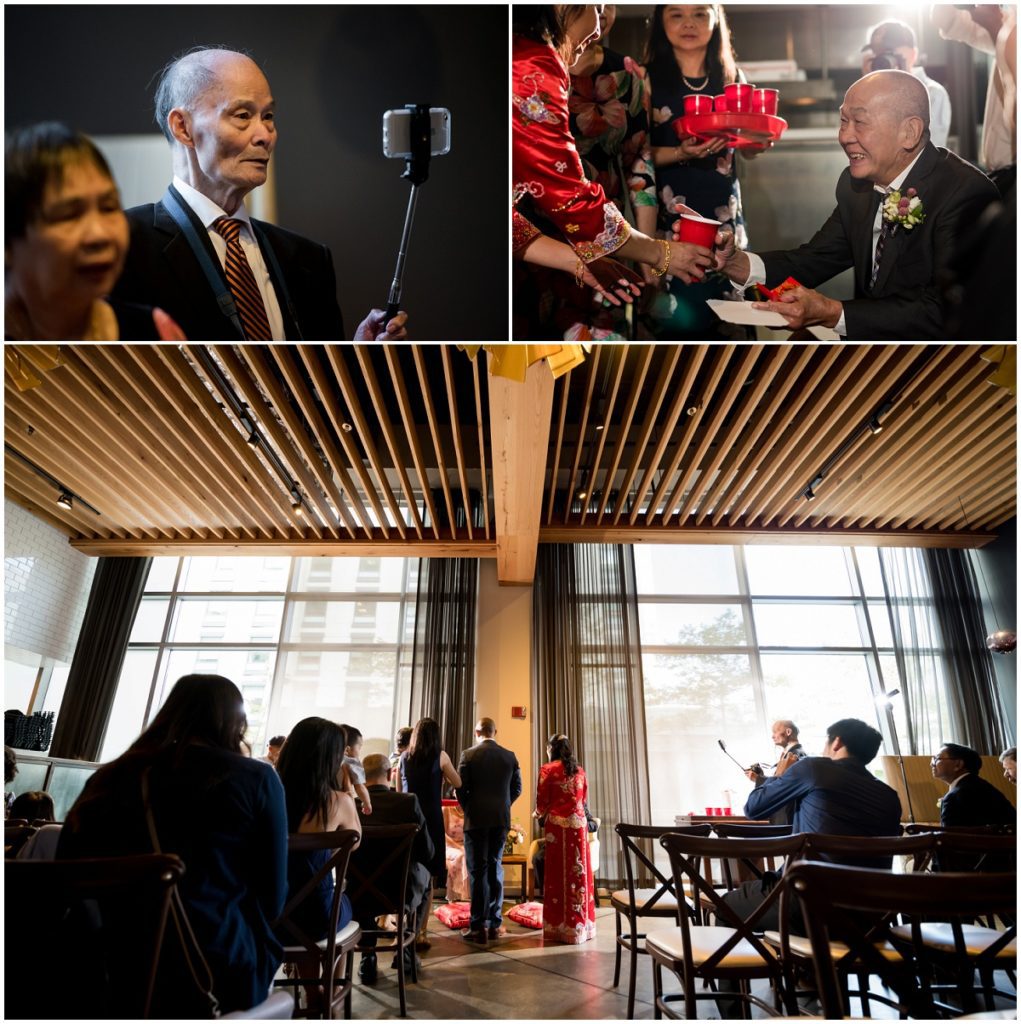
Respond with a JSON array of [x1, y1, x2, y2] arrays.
[[411, 558, 478, 765]]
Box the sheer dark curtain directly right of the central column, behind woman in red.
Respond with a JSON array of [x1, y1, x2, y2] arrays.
[[531, 544, 651, 886]]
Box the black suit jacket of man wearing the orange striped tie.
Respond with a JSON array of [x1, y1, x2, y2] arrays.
[[113, 186, 346, 341]]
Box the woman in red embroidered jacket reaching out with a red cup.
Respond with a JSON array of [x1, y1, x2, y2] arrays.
[[511, 4, 712, 340]]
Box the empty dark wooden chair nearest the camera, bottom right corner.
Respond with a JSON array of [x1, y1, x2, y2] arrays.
[[788, 861, 1017, 1020]]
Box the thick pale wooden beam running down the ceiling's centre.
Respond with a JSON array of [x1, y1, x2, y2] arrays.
[[490, 359, 553, 584]]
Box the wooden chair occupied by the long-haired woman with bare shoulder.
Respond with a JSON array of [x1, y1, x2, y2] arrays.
[[273, 828, 361, 1020]]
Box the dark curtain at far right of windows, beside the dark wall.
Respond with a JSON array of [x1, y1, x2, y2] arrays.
[[925, 548, 1008, 754]]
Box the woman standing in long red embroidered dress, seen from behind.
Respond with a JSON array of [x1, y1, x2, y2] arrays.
[[535, 733, 596, 943]]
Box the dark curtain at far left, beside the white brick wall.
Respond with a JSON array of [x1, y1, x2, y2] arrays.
[[49, 558, 153, 761]]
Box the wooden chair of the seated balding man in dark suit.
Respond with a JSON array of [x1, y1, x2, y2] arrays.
[[347, 823, 419, 1017]]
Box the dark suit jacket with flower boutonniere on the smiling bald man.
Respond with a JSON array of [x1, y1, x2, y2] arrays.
[[761, 142, 999, 341]]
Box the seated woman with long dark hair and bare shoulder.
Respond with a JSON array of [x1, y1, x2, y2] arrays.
[[276, 718, 361, 939]]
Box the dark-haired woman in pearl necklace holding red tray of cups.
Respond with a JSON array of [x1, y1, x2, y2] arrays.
[[645, 4, 749, 339]]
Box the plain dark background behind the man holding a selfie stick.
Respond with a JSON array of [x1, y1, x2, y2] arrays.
[[4, 4, 509, 341]]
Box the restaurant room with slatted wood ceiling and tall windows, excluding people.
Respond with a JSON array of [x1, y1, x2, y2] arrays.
[[4, 343, 1017, 1019]]
